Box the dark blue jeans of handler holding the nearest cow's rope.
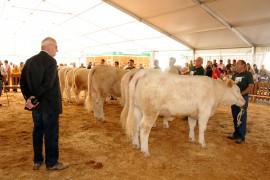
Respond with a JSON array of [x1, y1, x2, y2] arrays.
[[231, 95, 249, 141]]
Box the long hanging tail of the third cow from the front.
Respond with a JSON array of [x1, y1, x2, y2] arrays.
[[84, 68, 96, 113]]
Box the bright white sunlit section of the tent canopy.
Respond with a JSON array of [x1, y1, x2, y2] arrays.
[[0, 0, 188, 64]]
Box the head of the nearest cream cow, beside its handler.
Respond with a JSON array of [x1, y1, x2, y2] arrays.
[[223, 79, 246, 107]]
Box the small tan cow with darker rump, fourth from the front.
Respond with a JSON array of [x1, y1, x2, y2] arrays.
[[72, 68, 90, 104]]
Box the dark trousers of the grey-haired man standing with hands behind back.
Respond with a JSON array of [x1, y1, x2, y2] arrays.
[[32, 110, 59, 167]]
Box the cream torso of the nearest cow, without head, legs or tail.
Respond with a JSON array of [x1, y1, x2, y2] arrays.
[[135, 70, 217, 117]]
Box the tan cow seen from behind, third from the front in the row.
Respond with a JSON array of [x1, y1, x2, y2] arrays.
[[85, 65, 127, 120]]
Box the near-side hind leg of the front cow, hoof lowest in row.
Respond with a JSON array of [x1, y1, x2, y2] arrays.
[[140, 115, 158, 157]]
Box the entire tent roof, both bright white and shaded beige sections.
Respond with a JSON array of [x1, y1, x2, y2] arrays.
[[0, 0, 270, 61]]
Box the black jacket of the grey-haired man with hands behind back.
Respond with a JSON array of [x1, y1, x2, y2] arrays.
[[20, 51, 62, 115]]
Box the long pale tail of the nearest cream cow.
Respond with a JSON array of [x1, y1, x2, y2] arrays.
[[126, 70, 147, 138]]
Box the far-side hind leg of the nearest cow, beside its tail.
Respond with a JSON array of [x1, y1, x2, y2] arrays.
[[132, 106, 142, 149]]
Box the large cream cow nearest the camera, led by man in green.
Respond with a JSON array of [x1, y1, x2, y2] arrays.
[[125, 70, 245, 157]]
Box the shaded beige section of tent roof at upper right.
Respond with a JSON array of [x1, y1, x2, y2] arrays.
[[106, 0, 270, 50]]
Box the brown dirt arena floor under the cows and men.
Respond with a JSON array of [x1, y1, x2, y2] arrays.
[[0, 92, 270, 180]]
